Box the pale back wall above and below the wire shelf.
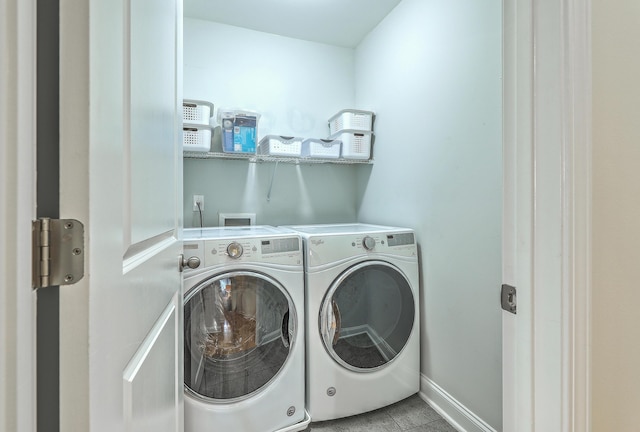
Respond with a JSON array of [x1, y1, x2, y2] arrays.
[[184, 19, 362, 227]]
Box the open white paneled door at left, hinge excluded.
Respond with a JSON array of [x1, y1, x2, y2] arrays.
[[60, 0, 183, 432]]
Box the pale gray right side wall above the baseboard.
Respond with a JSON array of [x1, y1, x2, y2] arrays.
[[356, 0, 502, 430]]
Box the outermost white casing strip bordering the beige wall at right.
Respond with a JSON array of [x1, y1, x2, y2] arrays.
[[562, 0, 592, 432]]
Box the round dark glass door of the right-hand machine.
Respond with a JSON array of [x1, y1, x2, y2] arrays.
[[319, 261, 415, 372]]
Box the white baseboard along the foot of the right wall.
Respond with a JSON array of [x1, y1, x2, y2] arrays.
[[419, 375, 496, 432]]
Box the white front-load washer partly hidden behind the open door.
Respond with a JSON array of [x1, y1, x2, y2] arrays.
[[184, 226, 309, 432]]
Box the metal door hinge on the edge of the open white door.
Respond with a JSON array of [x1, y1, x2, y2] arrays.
[[31, 218, 84, 288]]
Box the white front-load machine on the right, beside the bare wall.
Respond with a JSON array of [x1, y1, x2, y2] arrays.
[[289, 224, 420, 421]]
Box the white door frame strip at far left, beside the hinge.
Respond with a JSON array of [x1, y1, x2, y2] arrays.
[[0, 0, 37, 431]]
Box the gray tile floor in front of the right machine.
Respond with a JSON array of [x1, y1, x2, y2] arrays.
[[303, 394, 456, 432]]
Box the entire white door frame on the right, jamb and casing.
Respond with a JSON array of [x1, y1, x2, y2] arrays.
[[503, 0, 592, 432]]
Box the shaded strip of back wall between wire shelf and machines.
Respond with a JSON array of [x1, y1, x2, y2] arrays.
[[183, 159, 371, 228]]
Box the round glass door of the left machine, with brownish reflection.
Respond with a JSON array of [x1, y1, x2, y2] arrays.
[[184, 272, 296, 401]]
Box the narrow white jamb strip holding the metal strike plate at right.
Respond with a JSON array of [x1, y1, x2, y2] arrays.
[[496, 0, 534, 432]]
